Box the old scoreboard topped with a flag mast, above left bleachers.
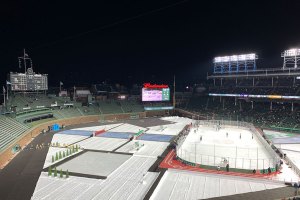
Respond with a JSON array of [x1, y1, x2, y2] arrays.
[[8, 50, 48, 92]]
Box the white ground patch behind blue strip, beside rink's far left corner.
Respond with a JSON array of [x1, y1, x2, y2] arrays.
[[146, 123, 188, 135]]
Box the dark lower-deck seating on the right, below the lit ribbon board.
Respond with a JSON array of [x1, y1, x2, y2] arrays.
[[181, 93, 300, 129]]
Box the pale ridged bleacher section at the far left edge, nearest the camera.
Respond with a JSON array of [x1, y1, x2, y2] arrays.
[[0, 116, 29, 151]]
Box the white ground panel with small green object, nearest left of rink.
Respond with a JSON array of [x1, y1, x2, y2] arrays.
[[117, 140, 169, 156]]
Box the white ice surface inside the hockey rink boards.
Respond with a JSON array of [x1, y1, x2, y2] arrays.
[[178, 126, 276, 169]]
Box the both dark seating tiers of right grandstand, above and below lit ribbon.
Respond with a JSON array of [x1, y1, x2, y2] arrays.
[[178, 76, 300, 130]]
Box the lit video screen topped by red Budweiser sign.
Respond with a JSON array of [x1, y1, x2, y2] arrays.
[[142, 84, 170, 101]]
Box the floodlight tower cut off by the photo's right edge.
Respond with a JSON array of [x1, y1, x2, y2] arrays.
[[281, 49, 300, 69]]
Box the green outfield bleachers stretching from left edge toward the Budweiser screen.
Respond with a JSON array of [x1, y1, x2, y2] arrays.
[[0, 94, 144, 150]]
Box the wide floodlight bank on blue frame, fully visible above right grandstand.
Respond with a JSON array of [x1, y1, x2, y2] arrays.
[[214, 53, 258, 74]]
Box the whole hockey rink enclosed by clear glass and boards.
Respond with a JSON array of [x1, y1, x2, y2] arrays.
[[176, 121, 279, 170]]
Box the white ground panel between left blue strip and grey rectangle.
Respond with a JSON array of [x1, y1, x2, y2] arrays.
[[77, 137, 128, 151]]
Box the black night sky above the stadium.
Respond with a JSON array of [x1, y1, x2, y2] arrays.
[[0, 0, 300, 86]]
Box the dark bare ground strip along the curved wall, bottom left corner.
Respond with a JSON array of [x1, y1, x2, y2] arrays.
[[0, 133, 53, 200]]
